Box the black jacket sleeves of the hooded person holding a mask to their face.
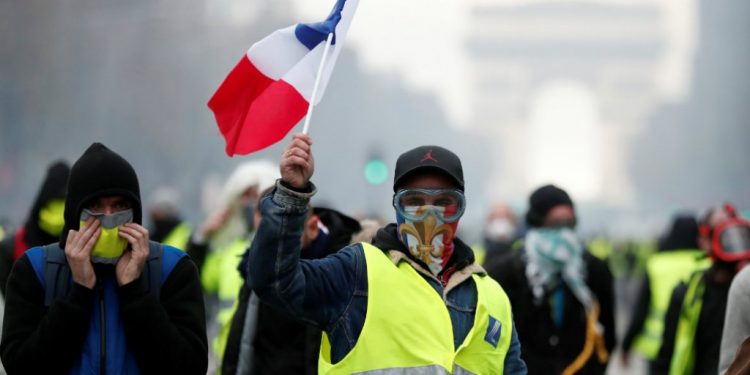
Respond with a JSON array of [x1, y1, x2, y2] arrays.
[[0, 255, 208, 374]]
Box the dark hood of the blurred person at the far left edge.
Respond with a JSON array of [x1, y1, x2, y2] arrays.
[[24, 160, 70, 247]]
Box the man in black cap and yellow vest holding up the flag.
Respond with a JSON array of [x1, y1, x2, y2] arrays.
[[247, 134, 526, 374]]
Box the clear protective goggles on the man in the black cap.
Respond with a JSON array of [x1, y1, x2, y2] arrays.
[[393, 189, 466, 223]]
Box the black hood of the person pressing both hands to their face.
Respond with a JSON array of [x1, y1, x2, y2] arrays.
[[60, 142, 142, 248]]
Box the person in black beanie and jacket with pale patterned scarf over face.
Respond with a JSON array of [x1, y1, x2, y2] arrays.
[[490, 185, 615, 374]]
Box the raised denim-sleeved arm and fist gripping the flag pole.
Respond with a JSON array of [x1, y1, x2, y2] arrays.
[[247, 134, 364, 329]]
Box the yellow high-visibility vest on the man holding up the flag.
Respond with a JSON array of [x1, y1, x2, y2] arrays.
[[318, 243, 513, 375]]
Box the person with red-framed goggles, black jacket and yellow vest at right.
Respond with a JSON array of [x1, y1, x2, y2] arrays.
[[652, 205, 750, 375]]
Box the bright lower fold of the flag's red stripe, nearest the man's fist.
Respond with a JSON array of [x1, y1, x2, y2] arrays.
[[232, 80, 308, 155]]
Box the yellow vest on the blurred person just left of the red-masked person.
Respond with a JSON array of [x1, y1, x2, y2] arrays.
[[633, 250, 710, 361]]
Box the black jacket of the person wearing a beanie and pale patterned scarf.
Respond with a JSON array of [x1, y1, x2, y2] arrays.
[[487, 250, 615, 375]]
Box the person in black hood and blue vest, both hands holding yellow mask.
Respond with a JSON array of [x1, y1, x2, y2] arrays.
[[0, 143, 207, 374]]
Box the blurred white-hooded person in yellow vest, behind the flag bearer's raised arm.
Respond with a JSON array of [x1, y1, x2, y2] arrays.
[[188, 160, 279, 366]]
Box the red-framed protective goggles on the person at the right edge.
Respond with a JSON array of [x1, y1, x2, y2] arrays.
[[701, 218, 750, 262]]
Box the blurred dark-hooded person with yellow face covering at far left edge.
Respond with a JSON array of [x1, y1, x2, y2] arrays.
[[0, 161, 70, 295]]
